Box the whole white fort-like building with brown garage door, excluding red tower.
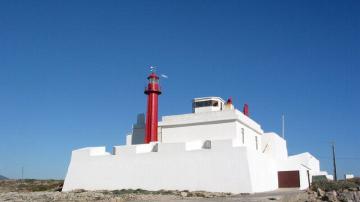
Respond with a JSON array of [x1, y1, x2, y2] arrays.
[[63, 97, 327, 193]]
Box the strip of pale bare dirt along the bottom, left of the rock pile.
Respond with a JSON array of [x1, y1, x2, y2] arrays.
[[0, 190, 307, 202]]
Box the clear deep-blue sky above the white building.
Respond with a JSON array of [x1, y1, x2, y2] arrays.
[[0, 0, 360, 178]]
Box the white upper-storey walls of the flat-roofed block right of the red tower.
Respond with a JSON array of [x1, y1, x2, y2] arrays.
[[159, 110, 263, 144]]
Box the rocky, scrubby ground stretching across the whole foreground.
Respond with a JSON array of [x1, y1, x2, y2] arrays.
[[0, 180, 360, 202]]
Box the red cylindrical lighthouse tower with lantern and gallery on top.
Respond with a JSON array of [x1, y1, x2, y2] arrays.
[[144, 72, 161, 143]]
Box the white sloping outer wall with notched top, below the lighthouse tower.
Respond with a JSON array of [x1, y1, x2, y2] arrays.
[[63, 140, 277, 193]]
